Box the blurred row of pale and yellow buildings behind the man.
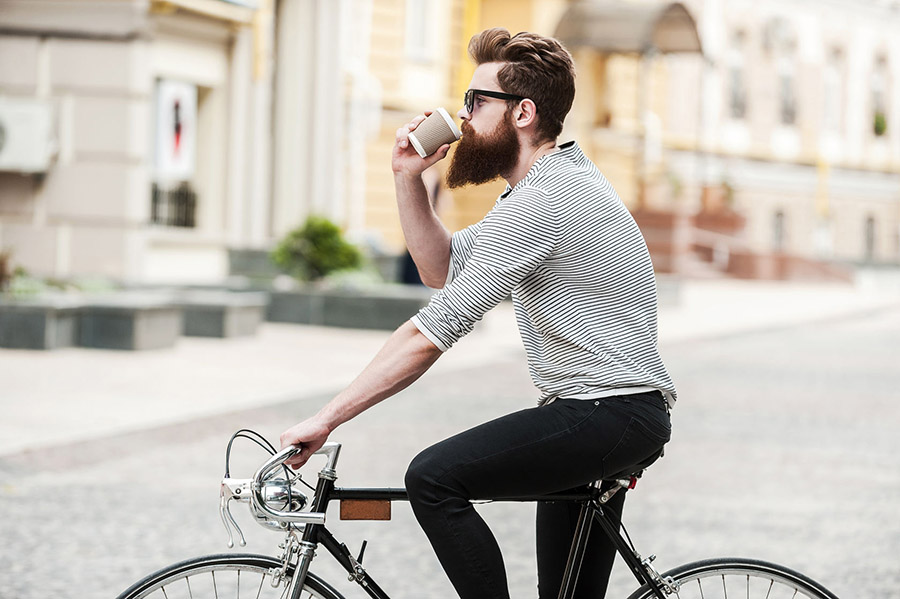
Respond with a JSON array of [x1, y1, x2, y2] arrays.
[[0, 0, 900, 283]]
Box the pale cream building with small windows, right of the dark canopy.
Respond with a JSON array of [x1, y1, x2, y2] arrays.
[[660, 0, 900, 274]]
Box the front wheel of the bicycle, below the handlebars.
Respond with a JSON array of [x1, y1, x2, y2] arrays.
[[117, 553, 344, 599]]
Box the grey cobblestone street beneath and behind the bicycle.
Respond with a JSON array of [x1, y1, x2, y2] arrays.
[[0, 310, 900, 599]]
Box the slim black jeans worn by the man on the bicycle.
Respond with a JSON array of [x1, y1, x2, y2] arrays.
[[406, 392, 671, 599]]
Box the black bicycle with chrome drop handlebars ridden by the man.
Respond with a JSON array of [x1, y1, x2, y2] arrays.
[[118, 430, 837, 599]]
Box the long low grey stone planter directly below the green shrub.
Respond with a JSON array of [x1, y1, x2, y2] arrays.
[[266, 285, 434, 330]]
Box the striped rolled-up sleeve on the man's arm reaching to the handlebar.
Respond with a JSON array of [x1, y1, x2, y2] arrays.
[[412, 189, 559, 351]]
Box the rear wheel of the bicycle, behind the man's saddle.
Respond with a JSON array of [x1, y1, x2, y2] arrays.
[[628, 557, 838, 599]]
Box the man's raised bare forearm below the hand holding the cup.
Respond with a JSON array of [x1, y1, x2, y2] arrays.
[[394, 173, 450, 288]]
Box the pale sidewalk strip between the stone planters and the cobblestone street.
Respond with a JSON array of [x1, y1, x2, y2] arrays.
[[0, 280, 900, 456]]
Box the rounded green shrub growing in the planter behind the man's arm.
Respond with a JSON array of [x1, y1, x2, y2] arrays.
[[272, 216, 362, 281]]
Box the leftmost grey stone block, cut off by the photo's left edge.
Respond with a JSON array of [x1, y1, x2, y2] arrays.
[[0, 297, 81, 349]]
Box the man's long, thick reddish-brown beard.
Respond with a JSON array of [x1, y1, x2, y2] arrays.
[[447, 110, 521, 189]]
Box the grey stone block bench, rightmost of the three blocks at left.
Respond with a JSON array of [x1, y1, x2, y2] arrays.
[[177, 289, 269, 337]]
